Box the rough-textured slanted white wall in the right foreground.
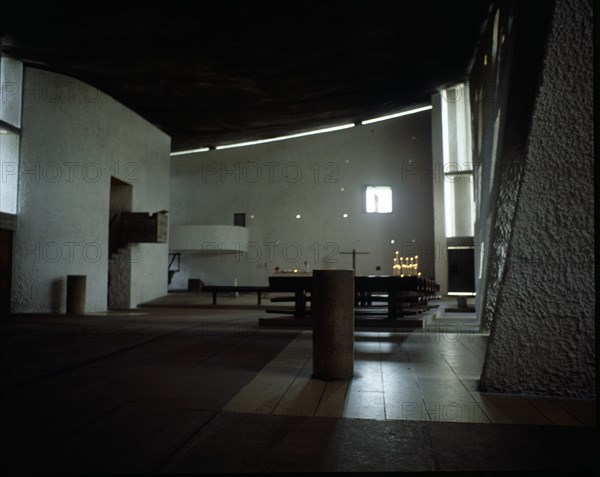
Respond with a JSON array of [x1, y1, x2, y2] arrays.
[[481, 0, 595, 397]]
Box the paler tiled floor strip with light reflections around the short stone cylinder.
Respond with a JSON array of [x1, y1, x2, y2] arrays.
[[223, 331, 595, 426]]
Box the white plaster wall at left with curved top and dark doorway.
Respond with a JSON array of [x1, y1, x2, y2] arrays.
[[12, 68, 170, 312]]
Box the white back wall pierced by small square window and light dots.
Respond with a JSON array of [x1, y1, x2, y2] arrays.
[[171, 111, 439, 288]]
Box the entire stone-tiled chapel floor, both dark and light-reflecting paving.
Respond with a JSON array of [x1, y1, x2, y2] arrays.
[[0, 302, 597, 474]]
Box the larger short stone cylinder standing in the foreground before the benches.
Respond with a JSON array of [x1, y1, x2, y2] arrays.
[[310, 270, 354, 380]]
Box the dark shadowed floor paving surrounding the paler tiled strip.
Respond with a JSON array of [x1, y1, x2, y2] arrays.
[[0, 309, 598, 474]]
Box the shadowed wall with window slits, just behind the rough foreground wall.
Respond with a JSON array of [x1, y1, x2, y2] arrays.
[[471, 0, 554, 332]]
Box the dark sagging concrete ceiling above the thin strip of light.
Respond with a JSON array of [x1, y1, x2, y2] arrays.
[[0, 0, 491, 151]]
